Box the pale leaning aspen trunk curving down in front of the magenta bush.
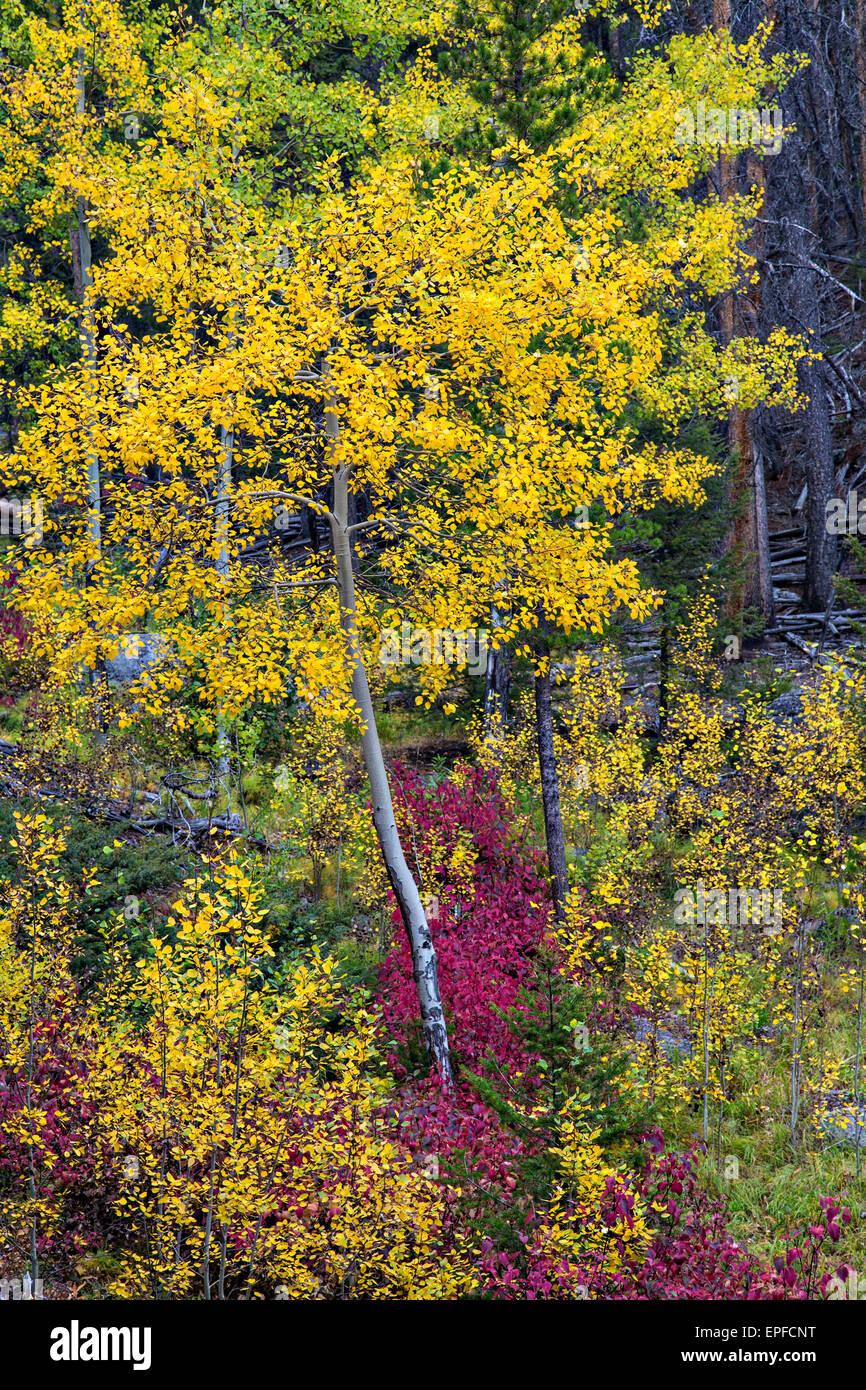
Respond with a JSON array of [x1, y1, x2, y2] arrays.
[[325, 386, 453, 1087]]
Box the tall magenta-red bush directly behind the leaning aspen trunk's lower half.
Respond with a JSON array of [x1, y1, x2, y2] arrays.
[[379, 767, 549, 1200]]
